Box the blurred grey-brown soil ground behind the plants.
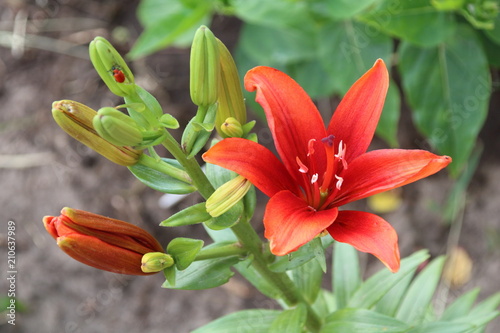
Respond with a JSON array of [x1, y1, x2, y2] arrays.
[[0, 0, 500, 333]]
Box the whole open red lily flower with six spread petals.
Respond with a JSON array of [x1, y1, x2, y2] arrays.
[[203, 59, 451, 272]]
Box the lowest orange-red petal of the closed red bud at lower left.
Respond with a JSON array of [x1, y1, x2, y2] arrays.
[[57, 233, 150, 275]]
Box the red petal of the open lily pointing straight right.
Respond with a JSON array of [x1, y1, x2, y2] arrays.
[[332, 149, 451, 206]]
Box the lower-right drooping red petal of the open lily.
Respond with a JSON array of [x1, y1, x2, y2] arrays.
[[327, 210, 399, 273]]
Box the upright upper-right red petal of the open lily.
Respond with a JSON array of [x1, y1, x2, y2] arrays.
[[327, 59, 389, 162]]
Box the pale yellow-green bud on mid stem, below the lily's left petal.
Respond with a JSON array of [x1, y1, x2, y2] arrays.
[[205, 176, 252, 217]]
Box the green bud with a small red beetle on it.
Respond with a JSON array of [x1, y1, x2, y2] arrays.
[[89, 37, 136, 97]]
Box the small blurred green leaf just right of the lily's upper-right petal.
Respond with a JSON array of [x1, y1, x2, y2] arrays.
[[376, 80, 401, 148]]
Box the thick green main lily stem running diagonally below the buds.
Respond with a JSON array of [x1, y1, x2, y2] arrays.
[[162, 133, 321, 332]]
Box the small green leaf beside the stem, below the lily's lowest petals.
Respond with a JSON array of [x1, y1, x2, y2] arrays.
[[291, 252, 323, 304]]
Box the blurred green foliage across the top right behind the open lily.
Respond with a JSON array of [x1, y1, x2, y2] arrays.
[[129, 0, 500, 177]]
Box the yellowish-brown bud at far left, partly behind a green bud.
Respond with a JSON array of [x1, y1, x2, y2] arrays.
[[52, 100, 142, 166]]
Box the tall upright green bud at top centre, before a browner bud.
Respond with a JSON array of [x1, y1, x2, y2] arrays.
[[189, 26, 220, 106]]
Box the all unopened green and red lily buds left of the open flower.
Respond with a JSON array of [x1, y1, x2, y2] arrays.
[[43, 26, 254, 275]]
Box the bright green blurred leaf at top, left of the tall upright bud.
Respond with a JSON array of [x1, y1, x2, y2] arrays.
[[128, 0, 212, 59]]
